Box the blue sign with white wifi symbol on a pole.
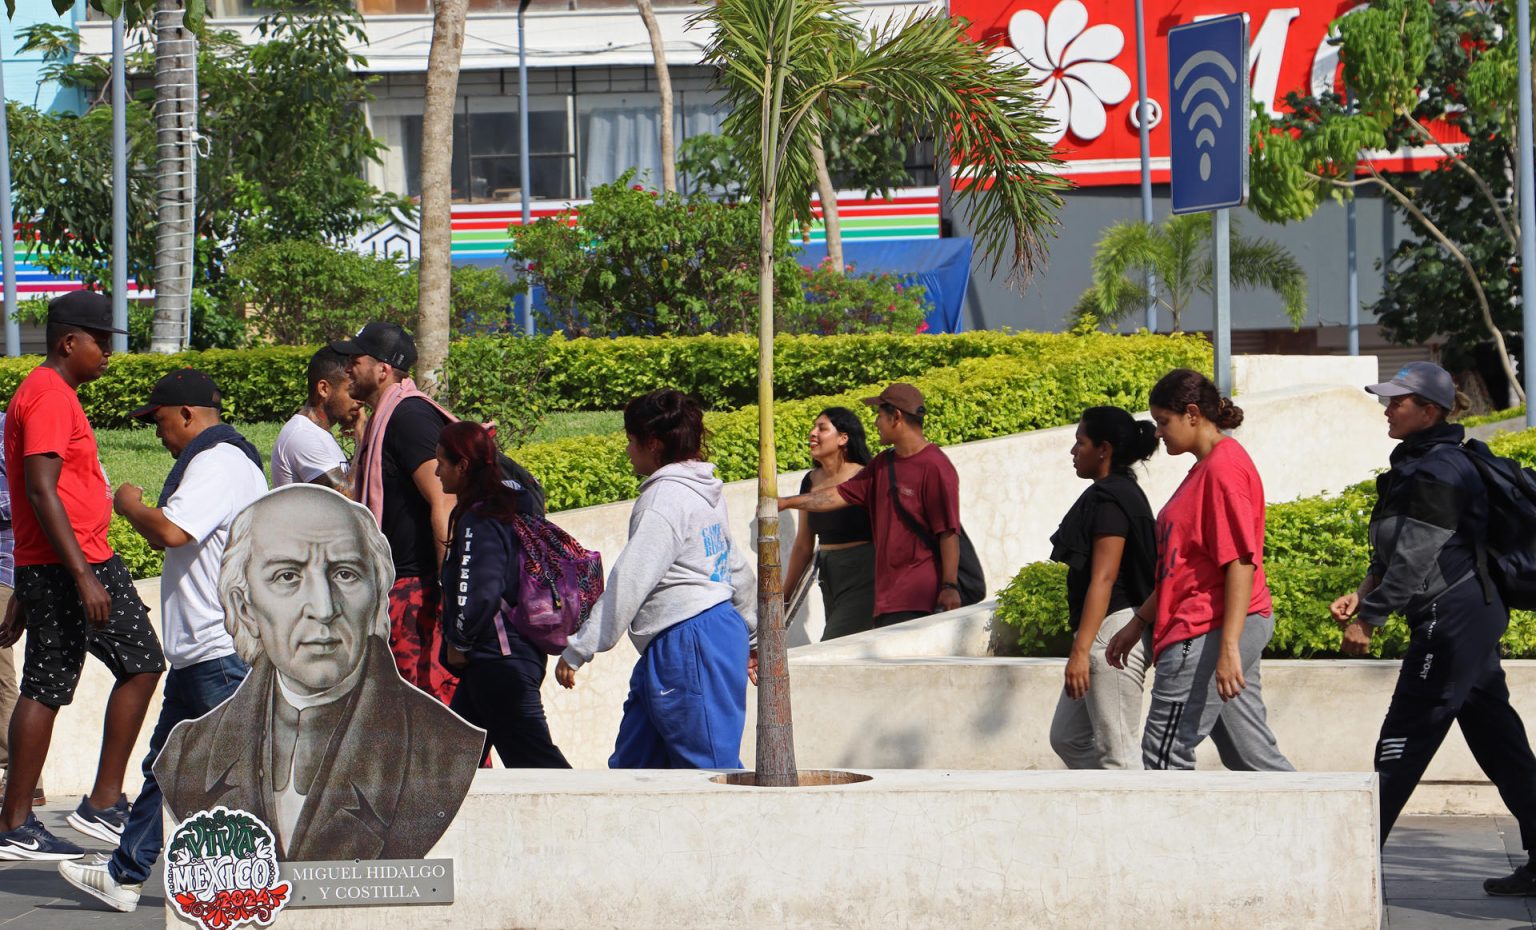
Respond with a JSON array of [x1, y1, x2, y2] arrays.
[[1167, 14, 1249, 214]]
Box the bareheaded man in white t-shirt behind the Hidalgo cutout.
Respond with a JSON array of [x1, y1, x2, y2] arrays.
[[272, 346, 362, 495]]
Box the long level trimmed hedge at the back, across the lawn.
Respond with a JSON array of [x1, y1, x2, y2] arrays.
[[0, 332, 1184, 435]]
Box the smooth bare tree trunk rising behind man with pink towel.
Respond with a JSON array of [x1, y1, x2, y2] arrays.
[[416, 0, 466, 394]]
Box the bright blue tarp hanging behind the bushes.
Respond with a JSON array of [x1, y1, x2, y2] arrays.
[[796, 238, 971, 332]]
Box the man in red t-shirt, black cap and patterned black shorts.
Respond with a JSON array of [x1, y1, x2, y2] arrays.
[[0, 291, 166, 859]]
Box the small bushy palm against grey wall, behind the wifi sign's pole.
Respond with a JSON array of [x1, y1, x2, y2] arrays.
[[1072, 214, 1307, 332]]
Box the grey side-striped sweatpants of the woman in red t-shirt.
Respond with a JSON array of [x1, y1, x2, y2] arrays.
[[1141, 613, 1296, 772]]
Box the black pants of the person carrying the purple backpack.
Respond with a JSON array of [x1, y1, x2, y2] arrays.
[[449, 658, 571, 769]]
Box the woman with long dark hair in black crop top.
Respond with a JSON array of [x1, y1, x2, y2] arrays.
[[783, 407, 874, 641]]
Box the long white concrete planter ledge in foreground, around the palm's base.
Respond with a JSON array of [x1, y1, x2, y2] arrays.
[[185, 770, 1381, 930]]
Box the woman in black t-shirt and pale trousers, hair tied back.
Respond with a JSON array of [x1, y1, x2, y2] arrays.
[[1051, 407, 1157, 769]]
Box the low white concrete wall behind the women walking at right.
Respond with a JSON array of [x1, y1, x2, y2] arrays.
[[742, 603, 1536, 815]]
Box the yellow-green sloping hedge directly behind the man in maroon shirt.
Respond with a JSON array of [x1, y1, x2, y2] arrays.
[[515, 334, 1210, 510]]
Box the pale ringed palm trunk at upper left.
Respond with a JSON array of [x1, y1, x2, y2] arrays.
[[149, 0, 197, 352]]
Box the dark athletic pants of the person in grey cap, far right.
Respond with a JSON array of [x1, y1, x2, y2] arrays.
[[1376, 576, 1536, 849]]
